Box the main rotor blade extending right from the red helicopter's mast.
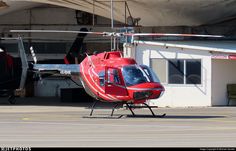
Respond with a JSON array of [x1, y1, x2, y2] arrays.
[[124, 33, 224, 38]]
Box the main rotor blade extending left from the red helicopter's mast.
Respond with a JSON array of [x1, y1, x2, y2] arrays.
[[10, 30, 104, 35]]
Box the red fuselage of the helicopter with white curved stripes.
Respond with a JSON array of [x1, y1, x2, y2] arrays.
[[80, 51, 164, 104]]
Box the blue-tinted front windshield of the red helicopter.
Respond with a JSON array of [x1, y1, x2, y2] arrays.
[[122, 65, 150, 86]]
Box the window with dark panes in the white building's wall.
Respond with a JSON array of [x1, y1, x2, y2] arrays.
[[151, 58, 202, 84]]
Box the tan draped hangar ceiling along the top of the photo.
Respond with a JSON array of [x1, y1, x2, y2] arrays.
[[0, 0, 236, 26]]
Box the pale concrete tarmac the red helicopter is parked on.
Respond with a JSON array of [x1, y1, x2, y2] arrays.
[[0, 98, 236, 147]]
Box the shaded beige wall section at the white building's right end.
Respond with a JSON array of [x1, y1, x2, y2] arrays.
[[212, 59, 236, 106]]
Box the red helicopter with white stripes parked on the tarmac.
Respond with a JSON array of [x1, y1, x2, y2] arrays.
[[11, 30, 222, 117]]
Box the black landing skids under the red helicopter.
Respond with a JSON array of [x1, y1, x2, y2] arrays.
[[84, 100, 166, 119]]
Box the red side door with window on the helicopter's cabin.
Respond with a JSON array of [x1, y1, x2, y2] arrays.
[[105, 67, 128, 96]]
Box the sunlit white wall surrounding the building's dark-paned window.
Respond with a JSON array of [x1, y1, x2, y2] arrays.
[[127, 44, 211, 107]]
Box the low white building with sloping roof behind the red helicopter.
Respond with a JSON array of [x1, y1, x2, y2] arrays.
[[124, 41, 236, 107]]
